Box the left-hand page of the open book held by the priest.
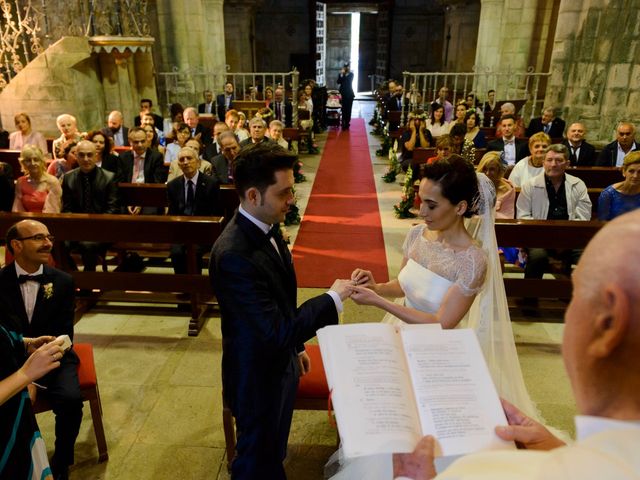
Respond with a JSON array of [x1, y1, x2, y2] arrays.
[[318, 323, 421, 458]]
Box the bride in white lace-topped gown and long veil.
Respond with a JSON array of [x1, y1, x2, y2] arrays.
[[330, 155, 539, 478]]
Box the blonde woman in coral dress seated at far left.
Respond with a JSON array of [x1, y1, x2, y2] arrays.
[[11, 145, 62, 213]]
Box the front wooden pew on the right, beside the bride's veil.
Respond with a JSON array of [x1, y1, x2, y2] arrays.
[[496, 219, 605, 298]]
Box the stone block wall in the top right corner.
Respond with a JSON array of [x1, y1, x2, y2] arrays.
[[546, 0, 640, 143]]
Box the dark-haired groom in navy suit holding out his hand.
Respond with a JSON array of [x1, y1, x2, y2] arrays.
[[209, 142, 350, 480]]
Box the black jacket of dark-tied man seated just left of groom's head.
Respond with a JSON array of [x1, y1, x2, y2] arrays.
[[167, 172, 222, 216]]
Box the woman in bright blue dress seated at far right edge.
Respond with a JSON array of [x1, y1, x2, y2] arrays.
[[598, 151, 640, 220]]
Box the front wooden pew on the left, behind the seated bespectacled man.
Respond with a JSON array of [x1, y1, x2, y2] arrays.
[[0, 213, 223, 336]]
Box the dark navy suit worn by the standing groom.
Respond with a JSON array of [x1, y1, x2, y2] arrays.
[[209, 212, 338, 480]]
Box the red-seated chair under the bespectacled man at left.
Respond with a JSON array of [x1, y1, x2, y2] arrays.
[[33, 343, 109, 463]]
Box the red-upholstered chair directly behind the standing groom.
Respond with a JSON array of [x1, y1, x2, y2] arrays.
[[222, 345, 329, 470]]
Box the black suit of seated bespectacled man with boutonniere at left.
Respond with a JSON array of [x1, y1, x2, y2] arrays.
[[0, 262, 82, 465]]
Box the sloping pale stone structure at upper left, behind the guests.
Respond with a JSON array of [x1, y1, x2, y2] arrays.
[[0, 37, 106, 137]]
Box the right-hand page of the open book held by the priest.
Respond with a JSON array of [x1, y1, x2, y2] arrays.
[[401, 328, 514, 456]]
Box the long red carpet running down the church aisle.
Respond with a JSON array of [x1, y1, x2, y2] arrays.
[[293, 118, 389, 287]]
